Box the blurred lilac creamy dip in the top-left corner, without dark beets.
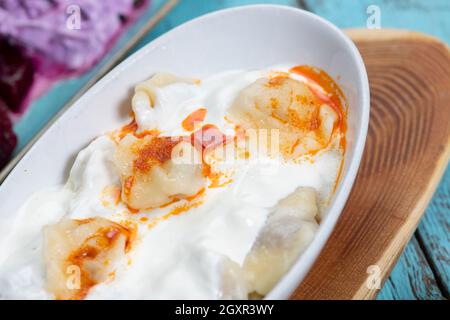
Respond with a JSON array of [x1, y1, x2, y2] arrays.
[[0, 0, 146, 75]]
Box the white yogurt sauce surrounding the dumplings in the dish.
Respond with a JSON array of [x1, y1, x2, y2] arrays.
[[0, 68, 341, 299]]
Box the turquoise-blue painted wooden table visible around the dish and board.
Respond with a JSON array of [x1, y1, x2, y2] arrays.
[[11, 0, 450, 299]]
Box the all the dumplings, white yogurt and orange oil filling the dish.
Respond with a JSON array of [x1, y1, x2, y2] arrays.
[[0, 66, 347, 299]]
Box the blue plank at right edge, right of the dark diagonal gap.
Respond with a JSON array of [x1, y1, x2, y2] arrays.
[[417, 167, 450, 298]]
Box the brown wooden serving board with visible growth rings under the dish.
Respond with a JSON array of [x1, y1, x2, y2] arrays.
[[291, 29, 450, 299]]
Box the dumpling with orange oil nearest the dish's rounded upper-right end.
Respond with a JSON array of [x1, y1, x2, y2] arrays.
[[227, 77, 338, 158]]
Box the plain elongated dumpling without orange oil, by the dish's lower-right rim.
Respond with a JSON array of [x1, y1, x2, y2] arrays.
[[243, 187, 318, 295]]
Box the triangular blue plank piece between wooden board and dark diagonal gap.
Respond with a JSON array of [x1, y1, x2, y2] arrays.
[[377, 237, 444, 300]]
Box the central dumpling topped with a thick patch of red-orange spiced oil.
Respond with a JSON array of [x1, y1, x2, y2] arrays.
[[115, 135, 206, 210]]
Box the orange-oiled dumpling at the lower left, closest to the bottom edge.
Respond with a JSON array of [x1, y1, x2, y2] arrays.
[[44, 217, 132, 300]]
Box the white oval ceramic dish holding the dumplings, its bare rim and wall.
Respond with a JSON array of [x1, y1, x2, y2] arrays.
[[0, 5, 370, 299]]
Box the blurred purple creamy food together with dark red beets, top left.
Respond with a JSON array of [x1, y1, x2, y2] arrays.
[[0, 0, 149, 115]]
